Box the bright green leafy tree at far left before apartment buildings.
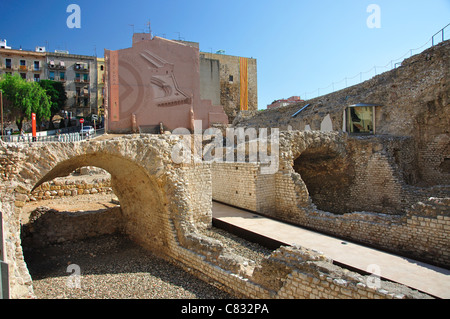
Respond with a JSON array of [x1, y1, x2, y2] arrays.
[[0, 74, 51, 130]]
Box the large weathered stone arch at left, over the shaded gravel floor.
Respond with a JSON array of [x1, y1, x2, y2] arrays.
[[0, 137, 188, 298]]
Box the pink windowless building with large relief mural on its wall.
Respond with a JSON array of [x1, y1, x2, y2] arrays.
[[105, 33, 228, 133]]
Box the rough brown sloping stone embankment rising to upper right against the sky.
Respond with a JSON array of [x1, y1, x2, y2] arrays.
[[233, 41, 450, 186]]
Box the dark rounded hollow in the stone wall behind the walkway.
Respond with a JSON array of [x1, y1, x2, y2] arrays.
[[294, 147, 353, 214]]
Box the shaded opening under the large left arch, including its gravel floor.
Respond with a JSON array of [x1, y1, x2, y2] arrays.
[[18, 154, 236, 299]]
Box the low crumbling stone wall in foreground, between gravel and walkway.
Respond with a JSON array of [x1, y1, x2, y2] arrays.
[[165, 238, 433, 299]]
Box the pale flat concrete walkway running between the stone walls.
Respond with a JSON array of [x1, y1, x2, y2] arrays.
[[213, 202, 450, 299]]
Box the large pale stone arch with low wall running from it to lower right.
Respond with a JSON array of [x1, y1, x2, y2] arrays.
[[0, 135, 436, 298]]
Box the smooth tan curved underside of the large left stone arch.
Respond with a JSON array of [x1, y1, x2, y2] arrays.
[[34, 153, 167, 252]]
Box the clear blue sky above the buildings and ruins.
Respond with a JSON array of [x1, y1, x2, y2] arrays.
[[0, 0, 450, 109]]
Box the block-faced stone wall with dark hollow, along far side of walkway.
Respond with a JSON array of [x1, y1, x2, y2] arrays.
[[212, 131, 450, 267]]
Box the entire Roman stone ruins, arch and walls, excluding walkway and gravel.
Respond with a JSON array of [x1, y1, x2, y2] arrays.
[[0, 41, 450, 299]]
